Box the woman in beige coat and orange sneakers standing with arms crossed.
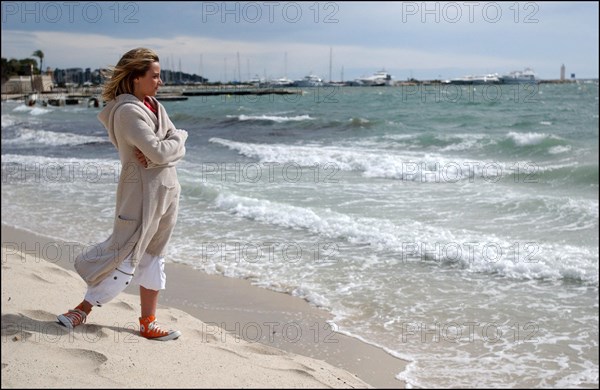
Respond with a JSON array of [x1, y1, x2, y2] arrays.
[[58, 48, 187, 341]]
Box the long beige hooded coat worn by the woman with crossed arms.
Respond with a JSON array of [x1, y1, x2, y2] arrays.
[[75, 94, 187, 286]]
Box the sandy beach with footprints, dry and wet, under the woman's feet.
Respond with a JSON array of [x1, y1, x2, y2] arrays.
[[2, 224, 406, 388]]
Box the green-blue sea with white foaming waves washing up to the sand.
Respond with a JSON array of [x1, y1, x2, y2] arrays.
[[2, 80, 599, 388]]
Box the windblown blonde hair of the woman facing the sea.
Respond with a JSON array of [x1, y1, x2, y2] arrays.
[[102, 47, 159, 102]]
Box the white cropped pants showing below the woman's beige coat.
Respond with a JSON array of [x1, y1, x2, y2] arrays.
[[84, 253, 167, 306]]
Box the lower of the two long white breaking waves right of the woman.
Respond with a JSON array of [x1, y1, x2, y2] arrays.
[[215, 193, 598, 284]]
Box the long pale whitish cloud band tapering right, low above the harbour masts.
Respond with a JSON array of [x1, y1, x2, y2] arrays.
[[2, 31, 564, 80]]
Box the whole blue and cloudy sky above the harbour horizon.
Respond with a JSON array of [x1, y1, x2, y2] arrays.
[[1, 1, 599, 81]]
